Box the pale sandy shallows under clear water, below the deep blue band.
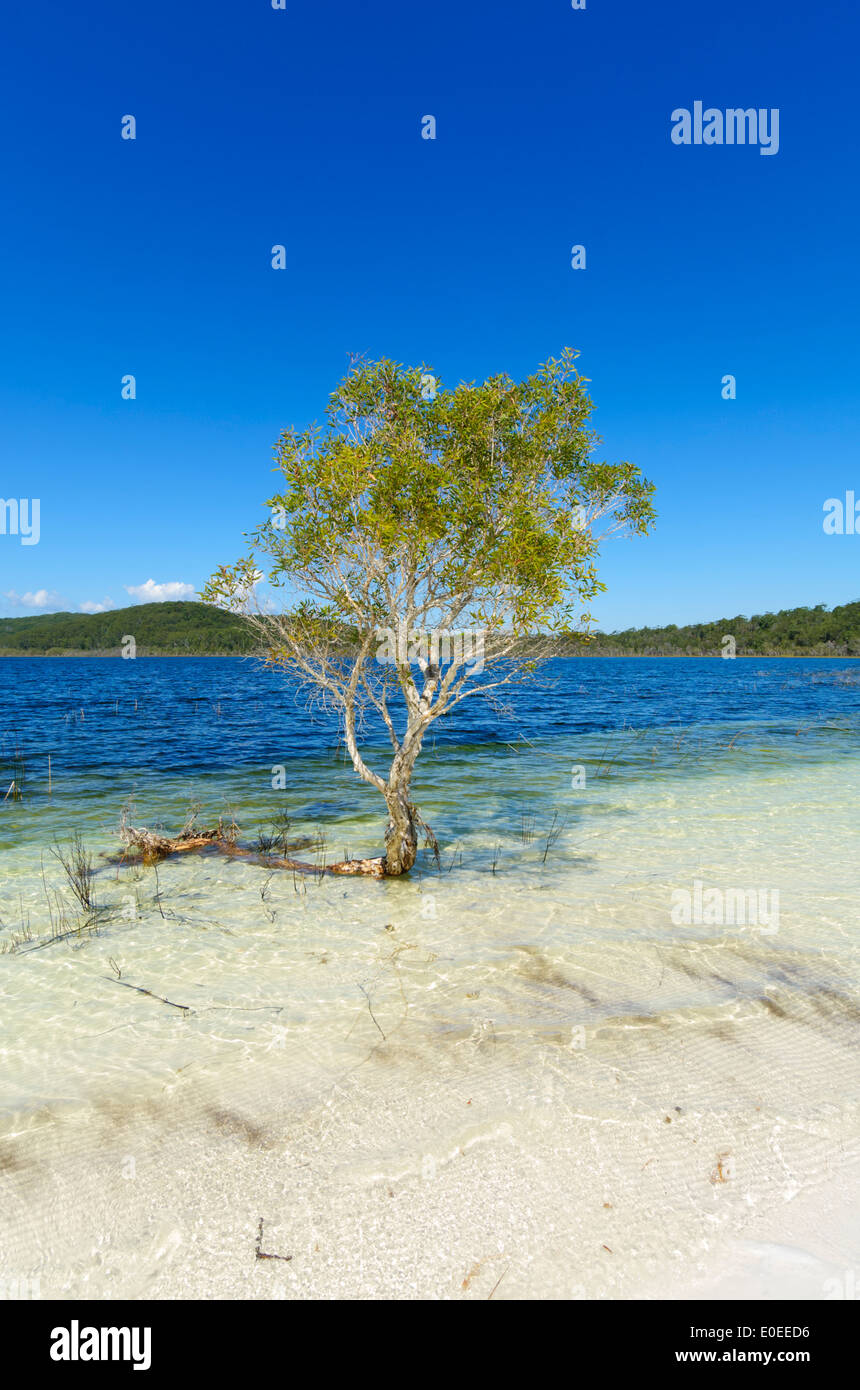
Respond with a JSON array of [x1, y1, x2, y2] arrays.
[[0, 658, 860, 1298]]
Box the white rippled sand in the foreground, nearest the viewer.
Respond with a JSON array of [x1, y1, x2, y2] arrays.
[[0, 945, 860, 1298]]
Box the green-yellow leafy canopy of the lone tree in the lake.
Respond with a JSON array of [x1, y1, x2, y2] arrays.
[[204, 349, 654, 635]]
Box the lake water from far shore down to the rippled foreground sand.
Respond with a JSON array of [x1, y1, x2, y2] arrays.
[[0, 659, 860, 1111]]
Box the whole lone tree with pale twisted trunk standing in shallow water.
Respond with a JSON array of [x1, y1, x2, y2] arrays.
[[201, 349, 654, 874]]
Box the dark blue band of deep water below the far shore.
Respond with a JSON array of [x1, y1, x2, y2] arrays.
[[0, 657, 860, 774]]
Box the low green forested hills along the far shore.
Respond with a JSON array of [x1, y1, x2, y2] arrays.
[[0, 600, 860, 657]]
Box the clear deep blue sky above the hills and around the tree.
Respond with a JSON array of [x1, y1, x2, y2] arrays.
[[0, 0, 860, 628]]
